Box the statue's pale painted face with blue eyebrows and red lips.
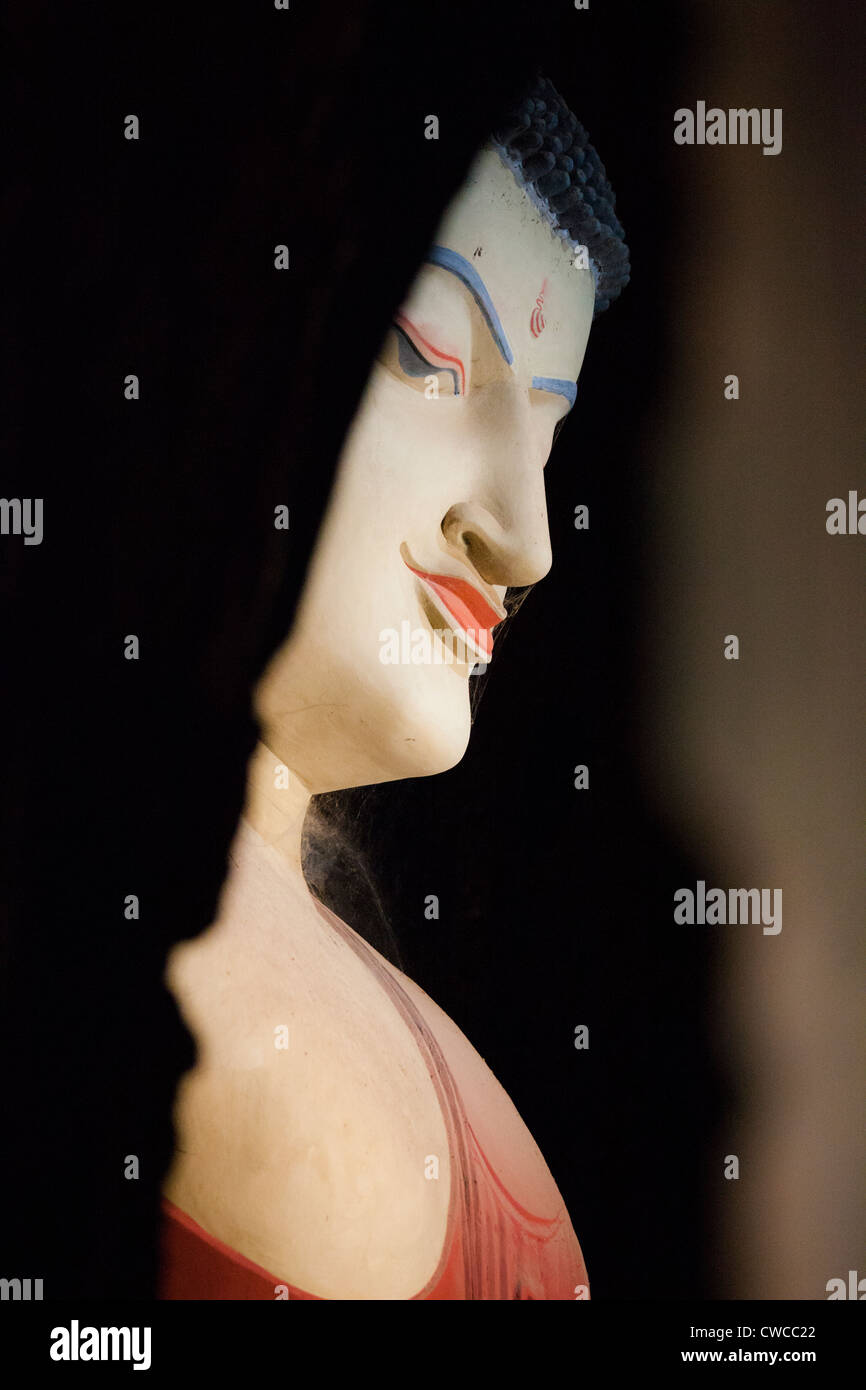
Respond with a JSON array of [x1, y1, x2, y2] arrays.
[[254, 150, 595, 792]]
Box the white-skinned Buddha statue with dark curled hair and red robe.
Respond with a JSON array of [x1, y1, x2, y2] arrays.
[[161, 78, 628, 1300]]
